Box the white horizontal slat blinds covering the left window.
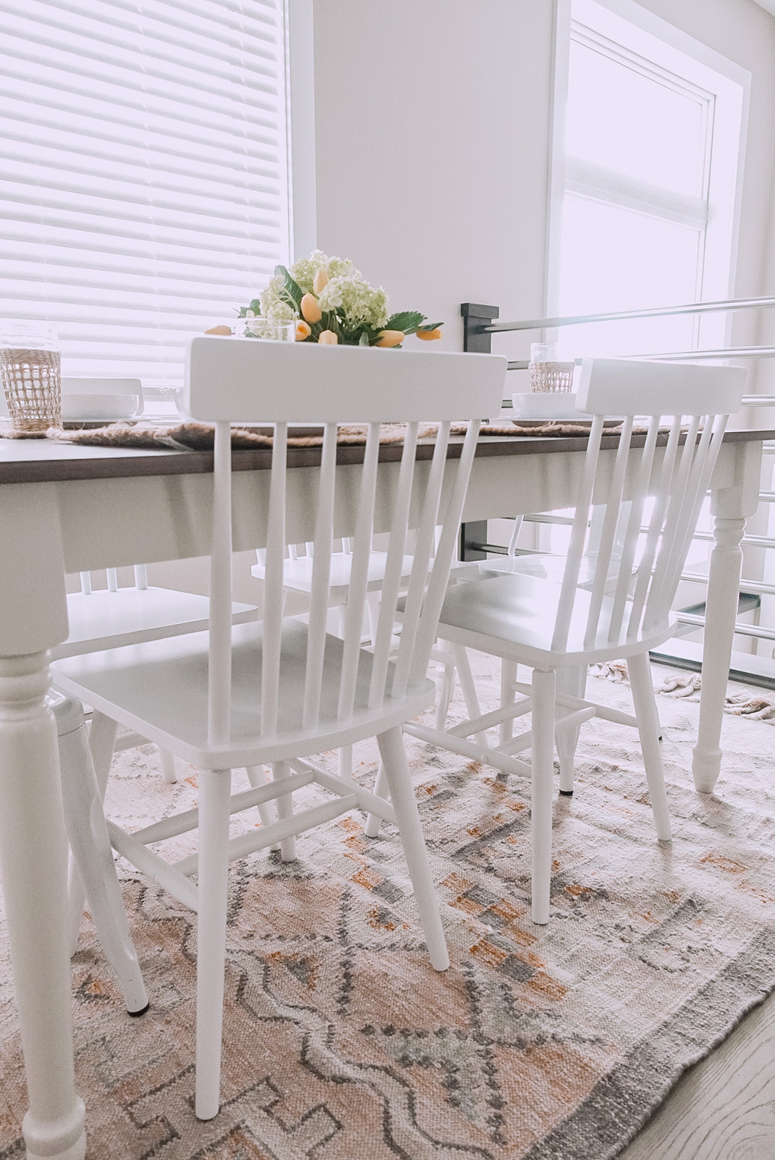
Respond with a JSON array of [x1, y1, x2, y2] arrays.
[[0, 0, 289, 389]]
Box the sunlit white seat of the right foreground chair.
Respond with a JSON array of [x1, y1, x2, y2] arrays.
[[439, 572, 674, 668]]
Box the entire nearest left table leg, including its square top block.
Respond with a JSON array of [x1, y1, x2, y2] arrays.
[[0, 484, 86, 1160]]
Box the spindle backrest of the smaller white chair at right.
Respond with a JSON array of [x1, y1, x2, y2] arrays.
[[552, 358, 747, 652]]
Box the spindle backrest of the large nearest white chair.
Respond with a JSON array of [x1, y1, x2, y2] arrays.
[[184, 336, 506, 744]]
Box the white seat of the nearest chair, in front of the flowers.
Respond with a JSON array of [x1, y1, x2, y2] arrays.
[[52, 618, 435, 769]]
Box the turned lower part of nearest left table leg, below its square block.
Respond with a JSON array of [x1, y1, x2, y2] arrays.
[[0, 653, 86, 1160]]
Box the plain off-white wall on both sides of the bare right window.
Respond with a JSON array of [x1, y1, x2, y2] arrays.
[[314, 0, 775, 371]]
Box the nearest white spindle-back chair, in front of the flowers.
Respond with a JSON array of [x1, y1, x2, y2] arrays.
[[53, 338, 506, 1119]]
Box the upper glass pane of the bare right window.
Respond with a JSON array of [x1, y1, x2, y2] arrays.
[[565, 41, 705, 197]]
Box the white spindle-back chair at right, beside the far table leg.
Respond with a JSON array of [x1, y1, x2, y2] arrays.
[[387, 358, 746, 923]]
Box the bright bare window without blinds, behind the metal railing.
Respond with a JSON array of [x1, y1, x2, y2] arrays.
[[548, 0, 748, 357]]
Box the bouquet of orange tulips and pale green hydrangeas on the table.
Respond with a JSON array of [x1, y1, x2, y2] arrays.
[[239, 249, 442, 347]]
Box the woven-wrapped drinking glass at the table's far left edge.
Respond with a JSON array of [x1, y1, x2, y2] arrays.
[[0, 347, 61, 435]]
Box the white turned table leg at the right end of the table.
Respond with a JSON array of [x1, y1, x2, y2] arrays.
[[691, 443, 761, 793]]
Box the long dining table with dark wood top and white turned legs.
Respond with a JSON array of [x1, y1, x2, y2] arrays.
[[0, 429, 775, 1160]]
